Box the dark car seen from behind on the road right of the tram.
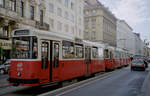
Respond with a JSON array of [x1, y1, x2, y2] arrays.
[[131, 59, 146, 71]]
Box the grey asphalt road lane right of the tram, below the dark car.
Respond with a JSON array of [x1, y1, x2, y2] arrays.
[[57, 67, 149, 96]]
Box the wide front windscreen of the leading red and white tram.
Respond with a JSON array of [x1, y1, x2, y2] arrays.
[[11, 37, 38, 59]]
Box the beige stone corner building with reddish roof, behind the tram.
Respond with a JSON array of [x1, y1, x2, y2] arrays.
[[84, 0, 117, 46]]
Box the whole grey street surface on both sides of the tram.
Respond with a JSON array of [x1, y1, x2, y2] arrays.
[[0, 67, 149, 96]]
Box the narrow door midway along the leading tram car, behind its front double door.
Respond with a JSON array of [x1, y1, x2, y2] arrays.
[[85, 46, 91, 74]]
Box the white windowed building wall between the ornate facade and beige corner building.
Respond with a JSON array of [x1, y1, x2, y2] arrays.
[[45, 0, 84, 39]]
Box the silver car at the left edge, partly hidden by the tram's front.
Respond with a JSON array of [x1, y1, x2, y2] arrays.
[[0, 59, 10, 74]]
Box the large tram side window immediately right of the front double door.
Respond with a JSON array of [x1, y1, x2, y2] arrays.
[[62, 41, 74, 59]]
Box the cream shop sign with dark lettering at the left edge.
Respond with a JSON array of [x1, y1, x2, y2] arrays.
[[0, 39, 11, 50]]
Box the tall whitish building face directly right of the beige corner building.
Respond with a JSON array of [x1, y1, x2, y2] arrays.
[[117, 20, 135, 54]]
